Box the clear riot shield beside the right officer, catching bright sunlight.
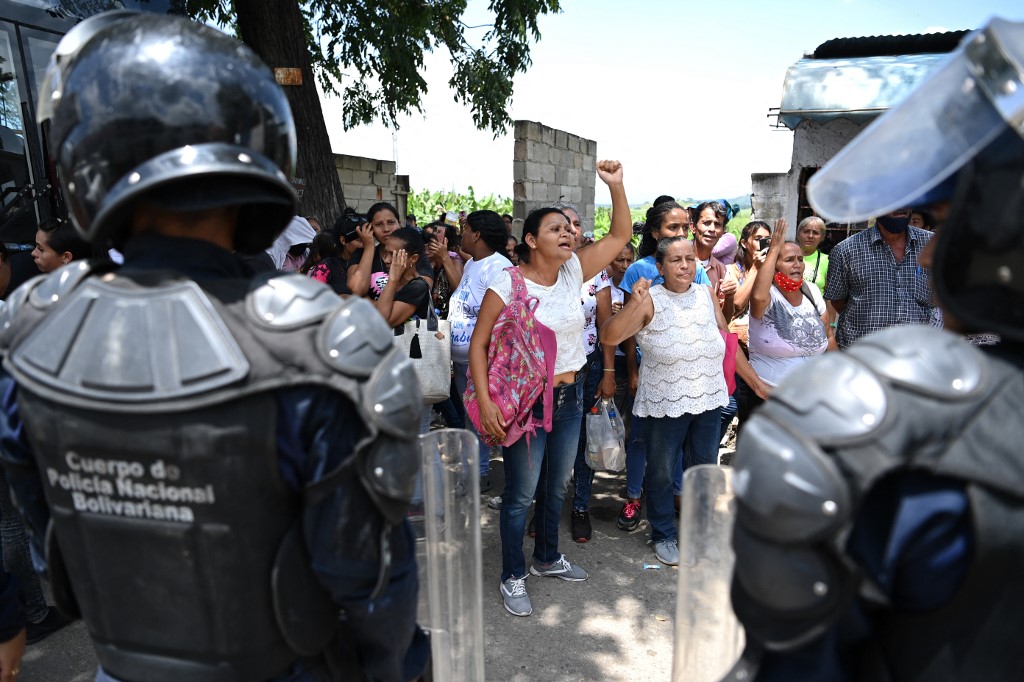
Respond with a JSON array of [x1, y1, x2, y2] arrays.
[[672, 464, 744, 682]]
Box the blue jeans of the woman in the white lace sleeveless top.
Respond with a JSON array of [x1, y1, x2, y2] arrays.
[[644, 408, 722, 542]]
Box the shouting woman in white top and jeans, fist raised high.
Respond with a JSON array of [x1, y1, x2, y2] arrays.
[[469, 161, 632, 615]]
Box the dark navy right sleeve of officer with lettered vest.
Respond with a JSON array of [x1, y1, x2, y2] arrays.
[[278, 389, 427, 680]]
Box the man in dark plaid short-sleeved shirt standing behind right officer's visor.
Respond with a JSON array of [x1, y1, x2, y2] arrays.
[[824, 210, 935, 348]]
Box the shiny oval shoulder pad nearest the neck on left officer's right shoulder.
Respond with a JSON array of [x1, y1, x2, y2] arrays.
[[246, 274, 344, 331]]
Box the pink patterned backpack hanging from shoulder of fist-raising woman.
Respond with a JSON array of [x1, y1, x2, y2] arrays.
[[463, 267, 557, 446]]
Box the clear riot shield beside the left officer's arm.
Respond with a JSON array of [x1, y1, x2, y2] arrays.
[[413, 429, 483, 682]]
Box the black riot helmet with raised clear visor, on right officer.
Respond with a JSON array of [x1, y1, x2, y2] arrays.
[[807, 18, 1024, 341]]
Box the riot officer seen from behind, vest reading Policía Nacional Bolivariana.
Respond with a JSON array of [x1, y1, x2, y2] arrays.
[[0, 13, 426, 682]]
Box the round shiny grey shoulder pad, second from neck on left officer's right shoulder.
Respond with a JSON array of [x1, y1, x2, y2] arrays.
[[316, 297, 394, 378]]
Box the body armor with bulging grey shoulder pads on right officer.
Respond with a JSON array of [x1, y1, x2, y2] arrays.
[[733, 327, 1024, 680]]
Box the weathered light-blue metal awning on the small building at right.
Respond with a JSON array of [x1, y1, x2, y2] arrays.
[[778, 53, 948, 130]]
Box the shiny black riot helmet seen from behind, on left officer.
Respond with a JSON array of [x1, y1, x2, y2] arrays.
[[39, 12, 296, 253]]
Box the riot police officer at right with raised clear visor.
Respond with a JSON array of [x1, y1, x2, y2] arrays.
[[731, 18, 1024, 680]]
